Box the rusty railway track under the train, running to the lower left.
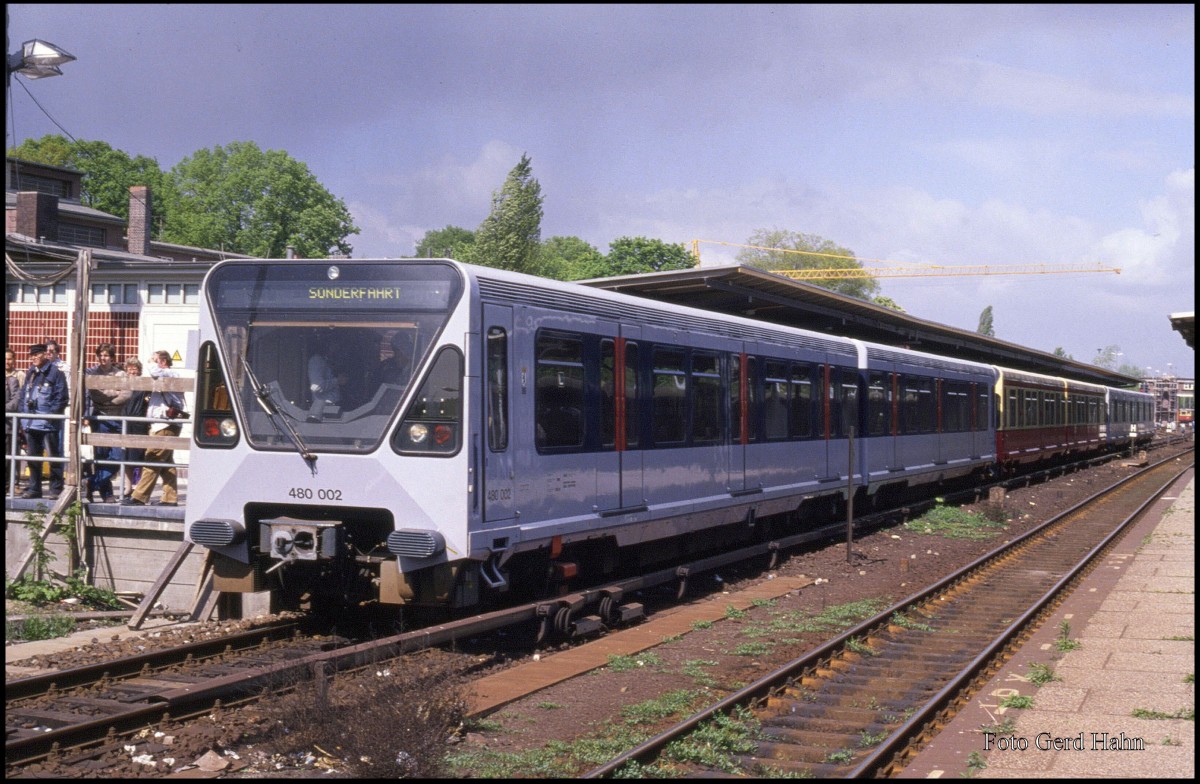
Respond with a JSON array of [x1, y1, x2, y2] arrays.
[[5, 439, 1190, 767]]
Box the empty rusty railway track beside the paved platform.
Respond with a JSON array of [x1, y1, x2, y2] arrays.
[[587, 449, 1192, 778]]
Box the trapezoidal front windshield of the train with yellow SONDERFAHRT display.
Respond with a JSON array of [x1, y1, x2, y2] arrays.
[[205, 261, 463, 453]]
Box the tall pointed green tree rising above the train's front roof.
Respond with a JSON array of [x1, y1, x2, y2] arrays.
[[462, 155, 542, 275]]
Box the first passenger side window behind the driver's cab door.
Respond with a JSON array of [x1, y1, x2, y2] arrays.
[[534, 333, 586, 449]]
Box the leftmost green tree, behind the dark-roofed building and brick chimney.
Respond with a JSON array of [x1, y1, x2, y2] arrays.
[[8, 134, 170, 226]]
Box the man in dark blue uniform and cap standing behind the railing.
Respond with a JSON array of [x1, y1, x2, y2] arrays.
[[18, 343, 67, 498]]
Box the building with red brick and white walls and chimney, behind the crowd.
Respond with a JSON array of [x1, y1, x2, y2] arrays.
[[5, 157, 246, 372]]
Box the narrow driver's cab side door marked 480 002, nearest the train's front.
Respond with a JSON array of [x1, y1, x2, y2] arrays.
[[480, 305, 517, 522]]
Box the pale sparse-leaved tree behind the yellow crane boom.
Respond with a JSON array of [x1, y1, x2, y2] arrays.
[[738, 228, 880, 300]]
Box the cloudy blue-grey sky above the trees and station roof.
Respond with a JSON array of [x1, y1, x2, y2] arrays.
[[5, 4, 1195, 377]]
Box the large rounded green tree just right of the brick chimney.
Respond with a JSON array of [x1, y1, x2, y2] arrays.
[[163, 142, 360, 258]]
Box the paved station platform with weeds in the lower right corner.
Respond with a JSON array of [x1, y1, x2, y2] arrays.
[[900, 472, 1195, 779]]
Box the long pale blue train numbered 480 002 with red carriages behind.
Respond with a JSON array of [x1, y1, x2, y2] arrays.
[[185, 258, 1153, 611]]
